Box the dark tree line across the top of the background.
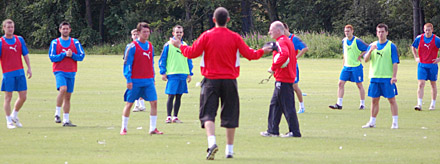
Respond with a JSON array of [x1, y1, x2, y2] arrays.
[[0, 0, 440, 48]]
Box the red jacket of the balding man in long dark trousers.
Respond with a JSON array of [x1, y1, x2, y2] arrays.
[[271, 35, 297, 83]]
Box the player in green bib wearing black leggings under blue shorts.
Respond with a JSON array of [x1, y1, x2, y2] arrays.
[[159, 25, 193, 123]]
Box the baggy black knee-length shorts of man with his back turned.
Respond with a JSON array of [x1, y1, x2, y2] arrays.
[[199, 78, 240, 128]]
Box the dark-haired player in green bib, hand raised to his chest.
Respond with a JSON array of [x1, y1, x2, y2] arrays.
[[362, 23, 399, 129]]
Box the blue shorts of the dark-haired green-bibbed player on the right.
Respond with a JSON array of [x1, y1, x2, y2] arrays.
[[368, 78, 397, 98]]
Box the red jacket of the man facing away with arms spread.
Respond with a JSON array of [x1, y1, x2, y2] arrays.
[[180, 27, 264, 79]]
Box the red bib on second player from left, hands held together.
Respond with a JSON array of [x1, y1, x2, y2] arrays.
[[52, 38, 78, 72]]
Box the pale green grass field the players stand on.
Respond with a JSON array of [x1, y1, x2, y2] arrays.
[[0, 55, 440, 163]]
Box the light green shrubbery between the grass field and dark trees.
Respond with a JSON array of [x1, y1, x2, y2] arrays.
[[31, 31, 413, 58]]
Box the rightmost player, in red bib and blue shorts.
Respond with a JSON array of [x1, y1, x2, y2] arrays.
[[411, 23, 440, 111]]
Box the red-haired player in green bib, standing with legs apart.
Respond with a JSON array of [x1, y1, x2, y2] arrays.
[[328, 25, 368, 110]]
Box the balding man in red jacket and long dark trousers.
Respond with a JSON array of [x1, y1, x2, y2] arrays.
[[260, 21, 301, 137]]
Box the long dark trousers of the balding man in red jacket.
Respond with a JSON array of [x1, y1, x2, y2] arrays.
[[267, 81, 301, 137]]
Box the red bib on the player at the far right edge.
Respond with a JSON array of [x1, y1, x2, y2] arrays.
[[419, 34, 438, 64]]
